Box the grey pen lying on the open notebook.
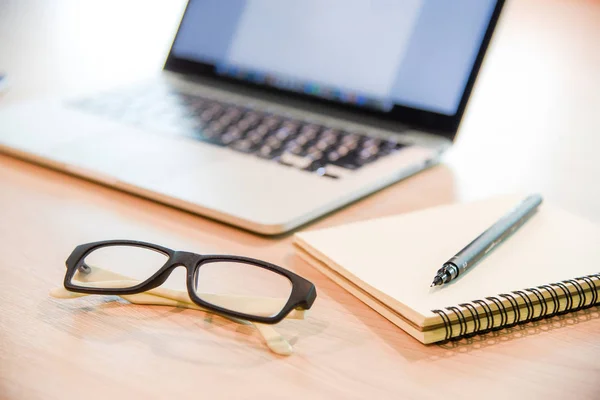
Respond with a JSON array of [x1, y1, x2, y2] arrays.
[[431, 194, 542, 287]]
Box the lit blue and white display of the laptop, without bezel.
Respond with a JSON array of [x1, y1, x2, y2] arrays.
[[172, 0, 497, 115]]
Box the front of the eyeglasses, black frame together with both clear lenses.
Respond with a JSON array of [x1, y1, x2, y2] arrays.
[[64, 240, 317, 324]]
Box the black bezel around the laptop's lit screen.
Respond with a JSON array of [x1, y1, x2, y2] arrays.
[[164, 0, 505, 140]]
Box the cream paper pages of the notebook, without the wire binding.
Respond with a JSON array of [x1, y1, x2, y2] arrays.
[[295, 196, 600, 343]]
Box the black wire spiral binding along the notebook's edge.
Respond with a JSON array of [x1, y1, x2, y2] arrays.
[[432, 273, 600, 340]]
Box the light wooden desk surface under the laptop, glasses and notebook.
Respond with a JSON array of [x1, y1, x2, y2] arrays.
[[0, 0, 600, 400]]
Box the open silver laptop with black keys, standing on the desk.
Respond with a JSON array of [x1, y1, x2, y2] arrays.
[[0, 0, 503, 235]]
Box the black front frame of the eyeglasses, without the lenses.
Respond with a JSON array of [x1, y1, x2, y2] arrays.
[[64, 240, 317, 324]]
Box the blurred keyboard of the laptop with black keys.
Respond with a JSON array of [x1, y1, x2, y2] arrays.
[[73, 85, 406, 178]]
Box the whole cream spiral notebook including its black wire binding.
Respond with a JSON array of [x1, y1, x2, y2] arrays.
[[294, 196, 600, 343]]
